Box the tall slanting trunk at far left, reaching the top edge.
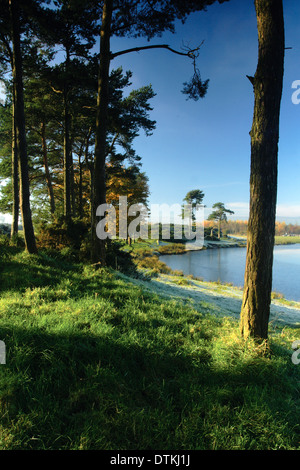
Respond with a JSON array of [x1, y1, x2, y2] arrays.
[[9, 0, 37, 253]]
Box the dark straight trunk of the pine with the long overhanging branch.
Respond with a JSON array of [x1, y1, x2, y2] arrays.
[[91, 0, 113, 265]]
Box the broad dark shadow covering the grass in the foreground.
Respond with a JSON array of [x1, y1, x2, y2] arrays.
[[0, 325, 299, 450]]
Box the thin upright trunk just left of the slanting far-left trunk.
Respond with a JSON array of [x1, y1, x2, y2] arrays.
[[10, 90, 20, 238]]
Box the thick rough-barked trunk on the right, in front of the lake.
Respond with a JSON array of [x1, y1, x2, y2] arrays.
[[241, 0, 284, 339]]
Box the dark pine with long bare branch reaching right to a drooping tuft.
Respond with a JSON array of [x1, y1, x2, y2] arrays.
[[92, 0, 230, 265]]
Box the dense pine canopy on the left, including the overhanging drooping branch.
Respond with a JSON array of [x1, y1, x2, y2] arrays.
[[0, 0, 228, 263]]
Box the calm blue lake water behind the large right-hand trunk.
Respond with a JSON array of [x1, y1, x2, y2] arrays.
[[160, 244, 300, 301]]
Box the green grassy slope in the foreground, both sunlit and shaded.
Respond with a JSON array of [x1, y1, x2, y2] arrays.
[[0, 241, 300, 450]]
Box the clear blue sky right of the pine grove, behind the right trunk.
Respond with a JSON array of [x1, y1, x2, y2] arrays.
[[111, 0, 300, 223]]
